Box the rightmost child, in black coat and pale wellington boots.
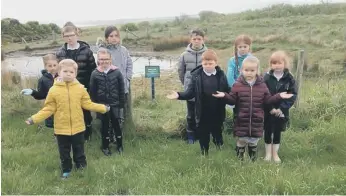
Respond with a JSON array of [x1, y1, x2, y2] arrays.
[[264, 51, 297, 163]]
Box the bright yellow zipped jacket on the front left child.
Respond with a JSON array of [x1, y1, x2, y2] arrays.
[[31, 79, 107, 135]]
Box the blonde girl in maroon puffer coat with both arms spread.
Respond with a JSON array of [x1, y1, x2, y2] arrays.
[[214, 56, 293, 161]]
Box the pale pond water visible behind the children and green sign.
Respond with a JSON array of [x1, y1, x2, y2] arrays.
[[2, 54, 176, 77]]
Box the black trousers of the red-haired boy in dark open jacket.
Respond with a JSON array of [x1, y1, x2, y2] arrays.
[[198, 120, 223, 151]]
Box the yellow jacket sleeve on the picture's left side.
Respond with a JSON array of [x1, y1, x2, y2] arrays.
[[31, 91, 57, 123]]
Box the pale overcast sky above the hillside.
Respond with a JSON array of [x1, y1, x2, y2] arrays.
[[1, 0, 346, 24]]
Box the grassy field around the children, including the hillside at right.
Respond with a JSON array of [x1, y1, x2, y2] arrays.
[[1, 3, 346, 195]]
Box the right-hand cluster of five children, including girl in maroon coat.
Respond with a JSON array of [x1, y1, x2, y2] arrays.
[[173, 30, 297, 163]]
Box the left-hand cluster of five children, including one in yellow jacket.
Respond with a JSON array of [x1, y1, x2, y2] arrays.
[[21, 23, 133, 179]]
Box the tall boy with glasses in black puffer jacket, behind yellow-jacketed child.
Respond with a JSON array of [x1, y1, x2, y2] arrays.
[[56, 25, 96, 141]]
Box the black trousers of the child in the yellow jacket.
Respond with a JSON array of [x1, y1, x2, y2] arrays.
[[56, 131, 87, 173]]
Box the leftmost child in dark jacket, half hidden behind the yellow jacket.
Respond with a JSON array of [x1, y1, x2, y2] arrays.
[[21, 54, 58, 128]]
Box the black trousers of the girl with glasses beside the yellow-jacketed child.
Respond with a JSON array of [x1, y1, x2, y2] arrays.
[[101, 108, 122, 149]]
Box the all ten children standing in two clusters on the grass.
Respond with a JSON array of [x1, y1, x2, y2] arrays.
[[21, 23, 297, 178]]
